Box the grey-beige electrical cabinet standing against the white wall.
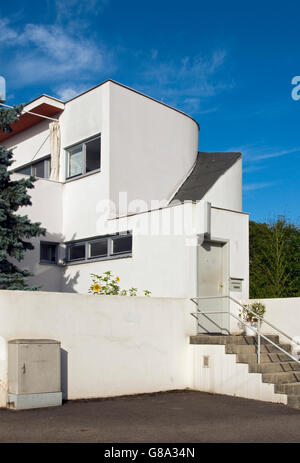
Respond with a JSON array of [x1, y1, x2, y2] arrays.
[[8, 339, 62, 409]]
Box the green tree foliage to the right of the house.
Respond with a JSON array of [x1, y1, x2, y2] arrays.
[[249, 216, 300, 299]]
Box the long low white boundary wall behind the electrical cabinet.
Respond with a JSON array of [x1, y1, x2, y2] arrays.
[[0, 291, 195, 407]]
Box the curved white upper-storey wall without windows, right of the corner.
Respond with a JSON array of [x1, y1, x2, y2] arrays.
[[109, 83, 199, 213]]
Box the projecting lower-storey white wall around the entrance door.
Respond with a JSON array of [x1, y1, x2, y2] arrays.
[[62, 203, 249, 299]]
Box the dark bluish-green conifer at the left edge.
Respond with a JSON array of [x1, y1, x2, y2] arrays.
[[0, 106, 46, 290]]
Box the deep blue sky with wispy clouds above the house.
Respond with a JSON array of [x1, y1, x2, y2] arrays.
[[0, 0, 300, 224]]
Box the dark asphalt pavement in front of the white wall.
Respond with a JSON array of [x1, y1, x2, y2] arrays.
[[0, 390, 300, 443]]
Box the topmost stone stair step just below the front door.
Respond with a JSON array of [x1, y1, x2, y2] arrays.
[[190, 334, 279, 345]]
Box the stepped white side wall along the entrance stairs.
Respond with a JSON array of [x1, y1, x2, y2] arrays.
[[191, 344, 287, 404]]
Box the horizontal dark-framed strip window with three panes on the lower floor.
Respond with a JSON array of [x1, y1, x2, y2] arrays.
[[66, 232, 132, 262]]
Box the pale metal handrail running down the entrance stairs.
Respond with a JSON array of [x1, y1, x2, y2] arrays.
[[191, 296, 300, 365]]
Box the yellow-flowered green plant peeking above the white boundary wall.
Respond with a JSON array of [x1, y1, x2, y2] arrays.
[[88, 271, 151, 296]]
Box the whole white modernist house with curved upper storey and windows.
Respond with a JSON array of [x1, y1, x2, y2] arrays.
[[0, 80, 249, 328]]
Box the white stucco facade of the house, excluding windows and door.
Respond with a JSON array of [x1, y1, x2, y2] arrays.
[[0, 81, 249, 299]]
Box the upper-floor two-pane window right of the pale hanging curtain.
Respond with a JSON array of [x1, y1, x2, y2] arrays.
[[66, 136, 101, 179]]
